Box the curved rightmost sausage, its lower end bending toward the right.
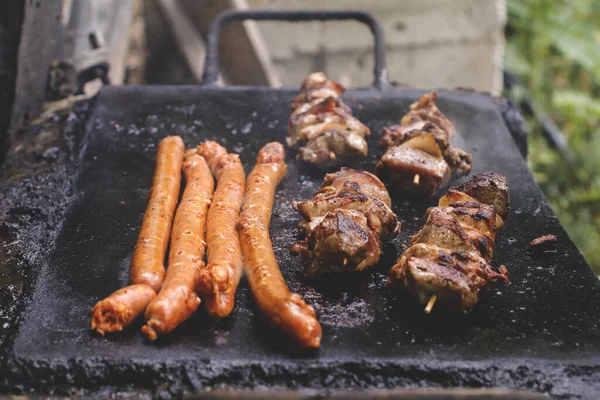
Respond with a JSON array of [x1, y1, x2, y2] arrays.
[[239, 142, 321, 348]]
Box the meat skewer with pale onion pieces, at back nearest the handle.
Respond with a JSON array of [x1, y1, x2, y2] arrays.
[[287, 72, 371, 169]]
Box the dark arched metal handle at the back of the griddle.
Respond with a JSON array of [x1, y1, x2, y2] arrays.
[[202, 10, 388, 89]]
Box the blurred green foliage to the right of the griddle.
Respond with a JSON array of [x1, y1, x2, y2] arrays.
[[505, 0, 600, 273]]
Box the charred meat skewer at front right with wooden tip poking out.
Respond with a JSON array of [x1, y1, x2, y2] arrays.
[[388, 172, 510, 314]]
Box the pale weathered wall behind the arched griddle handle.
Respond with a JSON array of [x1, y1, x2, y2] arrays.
[[248, 0, 506, 94]]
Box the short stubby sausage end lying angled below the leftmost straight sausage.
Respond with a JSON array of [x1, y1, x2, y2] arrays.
[[90, 283, 156, 335]]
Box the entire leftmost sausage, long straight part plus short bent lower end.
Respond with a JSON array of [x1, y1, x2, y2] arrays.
[[90, 136, 184, 335]]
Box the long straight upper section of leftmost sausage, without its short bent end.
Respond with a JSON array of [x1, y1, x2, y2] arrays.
[[130, 136, 184, 292]]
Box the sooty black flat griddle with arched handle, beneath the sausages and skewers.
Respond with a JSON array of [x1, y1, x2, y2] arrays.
[[0, 11, 600, 398]]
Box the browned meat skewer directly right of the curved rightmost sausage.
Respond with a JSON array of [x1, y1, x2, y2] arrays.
[[291, 168, 400, 277]]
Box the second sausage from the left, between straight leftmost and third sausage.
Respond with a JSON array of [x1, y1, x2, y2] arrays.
[[142, 155, 214, 340]]
